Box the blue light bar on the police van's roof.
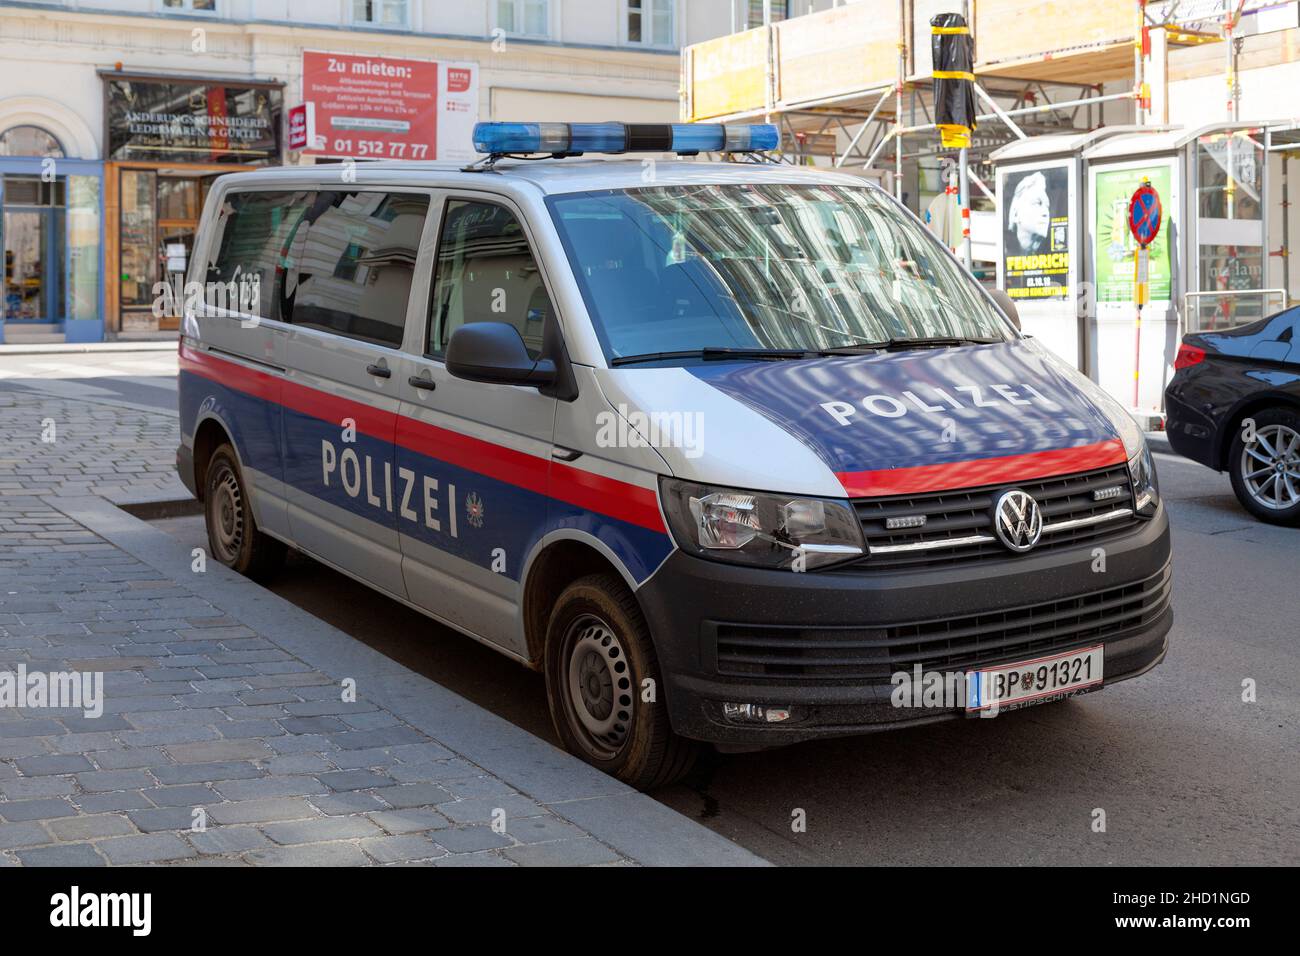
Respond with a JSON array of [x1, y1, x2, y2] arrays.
[[475, 122, 780, 156]]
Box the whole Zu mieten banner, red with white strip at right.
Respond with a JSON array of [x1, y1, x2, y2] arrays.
[[303, 51, 478, 161]]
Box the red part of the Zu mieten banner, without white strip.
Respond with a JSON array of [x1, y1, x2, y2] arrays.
[[303, 51, 449, 160]]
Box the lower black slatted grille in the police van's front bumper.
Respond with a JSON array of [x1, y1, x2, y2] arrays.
[[711, 564, 1171, 684]]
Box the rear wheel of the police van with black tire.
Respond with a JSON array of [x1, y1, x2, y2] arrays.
[[203, 442, 286, 580]]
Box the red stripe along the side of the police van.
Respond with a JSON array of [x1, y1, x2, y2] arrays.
[[181, 346, 667, 532]]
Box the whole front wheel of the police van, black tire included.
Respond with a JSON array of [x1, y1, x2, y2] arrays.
[[545, 574, 699, 790]]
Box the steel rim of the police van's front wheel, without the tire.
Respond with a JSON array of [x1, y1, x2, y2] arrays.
[[563, 614, 636, 760]]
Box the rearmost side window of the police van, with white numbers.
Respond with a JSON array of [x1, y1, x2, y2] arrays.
[[204, 191, 315, 321]]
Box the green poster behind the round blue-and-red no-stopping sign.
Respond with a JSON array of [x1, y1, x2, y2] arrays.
[[1093, 165, 1173, 302]]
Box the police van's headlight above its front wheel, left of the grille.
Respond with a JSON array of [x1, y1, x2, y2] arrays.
[[659, 479, 863, 571]]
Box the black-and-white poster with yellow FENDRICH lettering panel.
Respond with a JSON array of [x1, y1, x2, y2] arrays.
[[1002, 165, 1071, 299]]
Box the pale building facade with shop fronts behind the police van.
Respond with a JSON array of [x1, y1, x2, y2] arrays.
[[0, 0, 738, 342]]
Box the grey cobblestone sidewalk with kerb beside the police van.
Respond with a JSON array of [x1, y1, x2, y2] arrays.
[[0, 386, 763, 866]]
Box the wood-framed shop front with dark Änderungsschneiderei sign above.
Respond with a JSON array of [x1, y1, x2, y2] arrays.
[[101, 73, 283, 338]]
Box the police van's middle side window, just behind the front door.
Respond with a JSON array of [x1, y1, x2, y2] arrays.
[[281, 190, 429, 347]]
